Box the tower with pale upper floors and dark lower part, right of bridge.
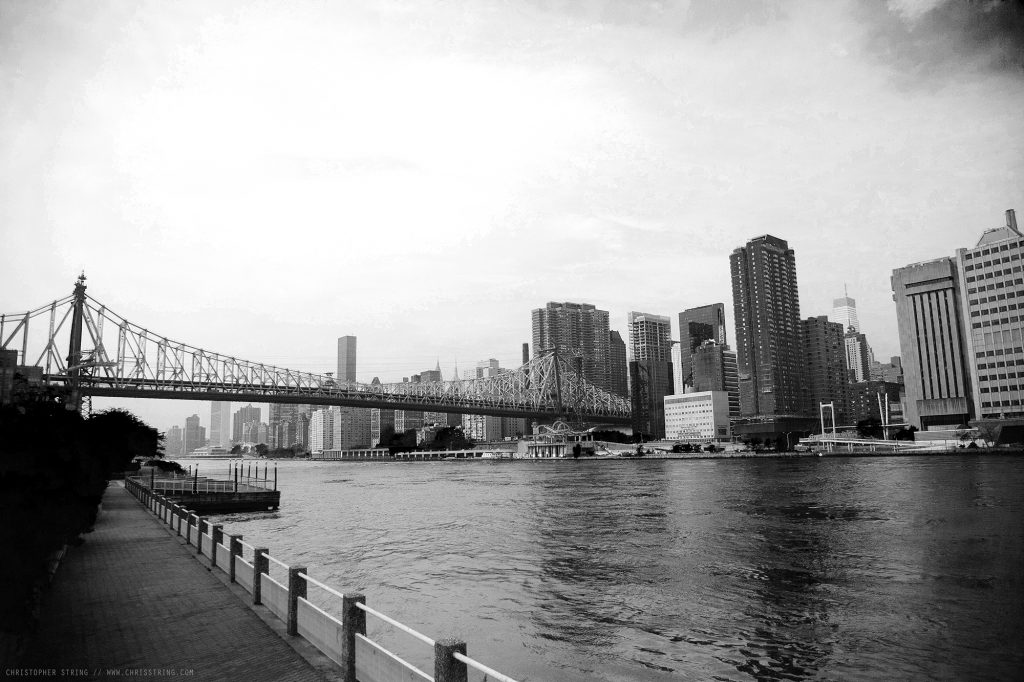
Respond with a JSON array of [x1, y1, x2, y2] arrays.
[[627, 312, 674, 438]]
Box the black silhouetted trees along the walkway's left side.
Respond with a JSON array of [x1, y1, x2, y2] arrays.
[[0, 394, 163, 636]]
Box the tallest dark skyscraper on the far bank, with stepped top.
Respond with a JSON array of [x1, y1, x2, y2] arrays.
[[729, 235, 809, 417]]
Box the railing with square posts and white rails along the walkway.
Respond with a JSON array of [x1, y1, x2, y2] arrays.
[[124, 476, 516, 682]]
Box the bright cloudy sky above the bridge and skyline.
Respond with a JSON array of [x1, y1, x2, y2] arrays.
[[0, 0, 1024, 429]]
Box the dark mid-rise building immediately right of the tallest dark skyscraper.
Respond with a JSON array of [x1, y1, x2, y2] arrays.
[[801, 315, 851, 425]]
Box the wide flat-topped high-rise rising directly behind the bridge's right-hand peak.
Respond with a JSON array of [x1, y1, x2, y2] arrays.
[[532, 302, 611, 390]]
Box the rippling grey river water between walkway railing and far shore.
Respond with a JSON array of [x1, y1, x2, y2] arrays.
[[184, 456, 1024, 682]]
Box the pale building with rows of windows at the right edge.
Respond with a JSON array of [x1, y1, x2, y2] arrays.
[[954, 209, 1024, 420]]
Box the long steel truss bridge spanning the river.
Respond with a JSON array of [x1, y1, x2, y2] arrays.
[[0, 274, 631, 424]]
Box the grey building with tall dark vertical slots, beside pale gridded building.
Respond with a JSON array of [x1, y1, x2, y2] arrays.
[[892, 258, 970, 430]]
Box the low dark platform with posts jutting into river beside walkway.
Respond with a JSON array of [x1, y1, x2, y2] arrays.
[[125, 467, 281, 514]]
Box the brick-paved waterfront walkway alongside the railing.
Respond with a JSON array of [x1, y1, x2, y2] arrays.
[[20, 482, 340, 681]]
